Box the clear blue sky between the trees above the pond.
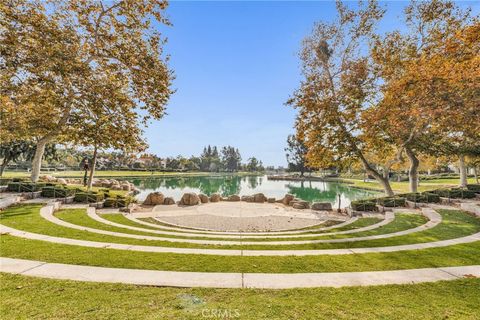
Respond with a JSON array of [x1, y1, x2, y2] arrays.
[[145, 1, 478, 166]]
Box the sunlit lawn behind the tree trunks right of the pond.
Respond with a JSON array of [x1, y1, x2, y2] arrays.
[[340, 178, 475, 192]]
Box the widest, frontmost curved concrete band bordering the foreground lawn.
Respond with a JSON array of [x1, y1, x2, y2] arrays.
[[0, 258, 480, 289]]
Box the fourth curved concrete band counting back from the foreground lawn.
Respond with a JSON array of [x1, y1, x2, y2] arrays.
[[87, 208, 395, 239]]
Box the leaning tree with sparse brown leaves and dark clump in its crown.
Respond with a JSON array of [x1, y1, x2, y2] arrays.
[[287, 1, 393, 195]]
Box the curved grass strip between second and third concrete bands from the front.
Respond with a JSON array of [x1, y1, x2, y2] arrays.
[[0, 205, 480, 250]]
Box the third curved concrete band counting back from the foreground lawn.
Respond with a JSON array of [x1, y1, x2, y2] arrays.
[[47, 207, 442, 245]]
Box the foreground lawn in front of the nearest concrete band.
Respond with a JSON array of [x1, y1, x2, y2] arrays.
[[0, 274, 480, 320]]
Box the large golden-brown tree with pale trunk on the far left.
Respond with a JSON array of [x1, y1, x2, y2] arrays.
[[0, 0, 172, 181]]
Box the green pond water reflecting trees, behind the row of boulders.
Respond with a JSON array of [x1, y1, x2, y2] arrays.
[[124, 175, 379, 208]]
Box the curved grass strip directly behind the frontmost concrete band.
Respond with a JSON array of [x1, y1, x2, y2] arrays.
[[0, 206, 480, 273]]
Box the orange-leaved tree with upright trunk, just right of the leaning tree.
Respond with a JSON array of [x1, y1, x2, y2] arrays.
[[369, 0, 478, 192]]
